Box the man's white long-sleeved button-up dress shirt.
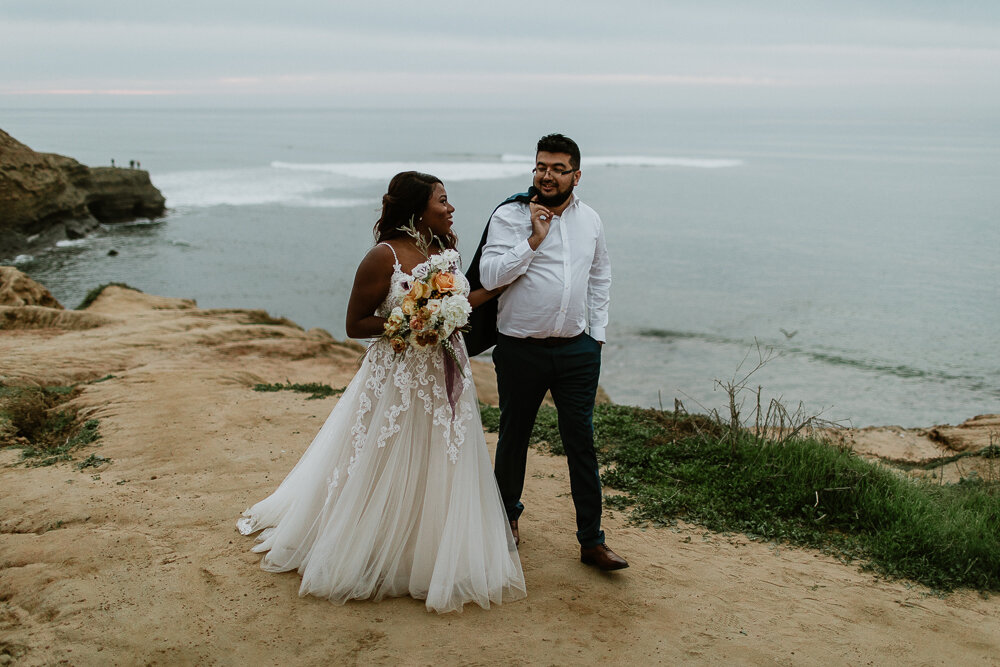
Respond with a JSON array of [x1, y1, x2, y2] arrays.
[[479, 195, 611, 343]]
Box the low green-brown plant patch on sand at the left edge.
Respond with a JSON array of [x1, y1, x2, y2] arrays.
[[0, 386, 100, 467]]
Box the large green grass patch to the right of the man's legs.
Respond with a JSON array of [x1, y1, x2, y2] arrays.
[[483, 405, 1000, 591]]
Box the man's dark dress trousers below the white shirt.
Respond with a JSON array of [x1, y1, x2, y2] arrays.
[[493, 334, 604, 547]]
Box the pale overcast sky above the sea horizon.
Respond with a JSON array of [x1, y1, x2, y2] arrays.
[[0, 0, 1000, 109]]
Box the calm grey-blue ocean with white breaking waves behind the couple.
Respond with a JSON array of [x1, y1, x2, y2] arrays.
[[0, 109, 1000, 427]]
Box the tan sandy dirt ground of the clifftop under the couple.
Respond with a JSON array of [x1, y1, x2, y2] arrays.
[[0, 288, 1000, 665]]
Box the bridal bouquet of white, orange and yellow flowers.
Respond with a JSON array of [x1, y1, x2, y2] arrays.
[[384, 250, 472, 368]]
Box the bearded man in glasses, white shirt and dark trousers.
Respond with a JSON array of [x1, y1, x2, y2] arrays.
[[479, 134, 628, 570]]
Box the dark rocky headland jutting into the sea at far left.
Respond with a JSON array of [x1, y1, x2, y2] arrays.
[[0, 130, 166, 255]]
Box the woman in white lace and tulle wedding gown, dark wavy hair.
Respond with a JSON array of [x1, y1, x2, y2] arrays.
[[237, 171, 525, 613]]
